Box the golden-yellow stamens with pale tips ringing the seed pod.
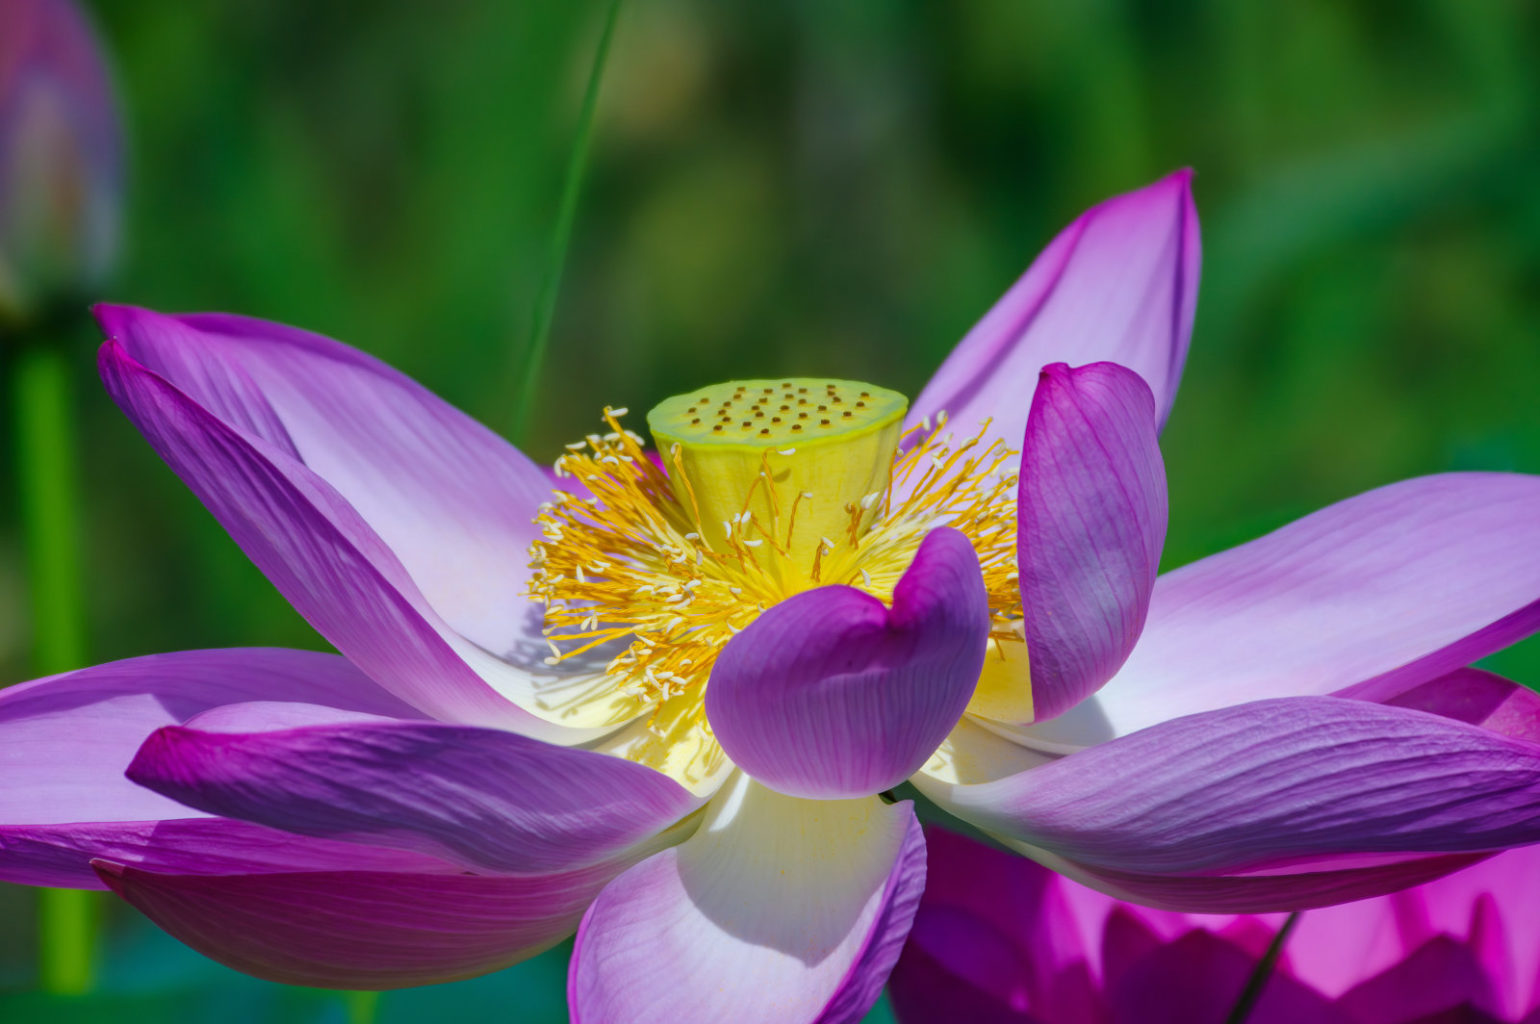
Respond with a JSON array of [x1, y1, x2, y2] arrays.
[[530, 394, 1021, 784]]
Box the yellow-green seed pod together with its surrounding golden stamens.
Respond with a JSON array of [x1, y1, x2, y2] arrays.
[[530, 379, 1024, 787]]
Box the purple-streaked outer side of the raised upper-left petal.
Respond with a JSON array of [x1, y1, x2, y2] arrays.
[[100, 335, 581, 741]]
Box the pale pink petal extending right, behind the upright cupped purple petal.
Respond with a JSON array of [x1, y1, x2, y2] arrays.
[[1095, 473, 1540, 735]]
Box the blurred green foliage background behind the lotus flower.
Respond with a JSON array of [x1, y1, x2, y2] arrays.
[[0, 0, 1540, 1021]]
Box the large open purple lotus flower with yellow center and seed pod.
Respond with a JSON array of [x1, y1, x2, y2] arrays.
[[0, 172, 1540, 1024]]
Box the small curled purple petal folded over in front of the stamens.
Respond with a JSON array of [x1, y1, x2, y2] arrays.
[[705, 527, 990, 799]]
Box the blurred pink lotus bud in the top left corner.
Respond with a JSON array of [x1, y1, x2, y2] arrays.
[[0, 0, 123, 322]]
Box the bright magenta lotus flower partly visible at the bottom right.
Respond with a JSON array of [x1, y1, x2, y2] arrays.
[[890, 828, 1540, 1024]]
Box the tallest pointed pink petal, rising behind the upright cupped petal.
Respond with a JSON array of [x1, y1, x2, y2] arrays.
[[909, 171, 1201, 448]]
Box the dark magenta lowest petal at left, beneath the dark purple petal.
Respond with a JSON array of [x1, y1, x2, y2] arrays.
[[97, 861, 619, 989]]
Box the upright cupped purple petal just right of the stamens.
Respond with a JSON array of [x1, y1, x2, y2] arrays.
[[1016, 363, 1166, 721]]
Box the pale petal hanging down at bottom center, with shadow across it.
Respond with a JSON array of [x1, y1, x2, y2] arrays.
[[568, 775, 926, 1024]]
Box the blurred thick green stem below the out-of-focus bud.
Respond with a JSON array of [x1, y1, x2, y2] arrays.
[[14, 345, 100, 995]]
